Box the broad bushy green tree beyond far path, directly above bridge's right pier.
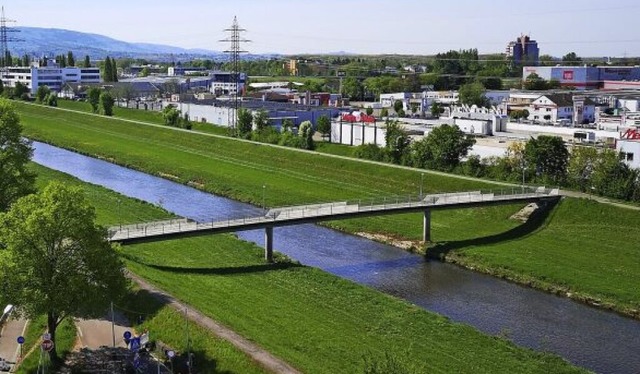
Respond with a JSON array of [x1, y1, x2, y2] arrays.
[[412, 124, 476, 171]]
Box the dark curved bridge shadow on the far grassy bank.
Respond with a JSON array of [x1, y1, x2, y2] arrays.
[[426, 199, 560, 260]]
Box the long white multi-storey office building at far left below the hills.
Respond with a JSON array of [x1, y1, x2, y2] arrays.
[[2, 62, 102, 95]]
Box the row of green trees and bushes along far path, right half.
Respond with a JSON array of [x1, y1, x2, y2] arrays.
[[353, 121, 640, 202]]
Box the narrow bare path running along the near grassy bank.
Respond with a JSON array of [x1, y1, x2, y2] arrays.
[[128, 272, 300, 374]]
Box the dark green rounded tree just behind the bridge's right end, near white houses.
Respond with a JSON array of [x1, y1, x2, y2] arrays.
[[524, 135, 569, 185]]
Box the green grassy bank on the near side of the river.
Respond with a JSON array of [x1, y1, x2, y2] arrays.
[[28, 167, 581, 373]]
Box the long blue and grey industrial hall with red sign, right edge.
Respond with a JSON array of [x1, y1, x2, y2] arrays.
[[522, 66, 640, 89]]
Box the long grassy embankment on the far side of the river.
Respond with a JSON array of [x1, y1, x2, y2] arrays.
[[17, 103, 640, 315]]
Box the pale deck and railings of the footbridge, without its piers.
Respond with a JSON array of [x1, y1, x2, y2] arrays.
[[109, 186, 558, 240]]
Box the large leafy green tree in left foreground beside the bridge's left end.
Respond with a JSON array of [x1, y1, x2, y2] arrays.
[[0, 182, 127, 362]]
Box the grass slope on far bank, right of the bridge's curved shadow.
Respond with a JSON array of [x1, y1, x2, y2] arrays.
[[448, 199, 640, 317]]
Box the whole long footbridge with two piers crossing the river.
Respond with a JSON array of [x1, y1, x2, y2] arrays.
[[108, 187, 560, 261]]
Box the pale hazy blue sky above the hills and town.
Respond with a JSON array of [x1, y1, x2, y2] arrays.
[[5, 0, 640, 57]]
